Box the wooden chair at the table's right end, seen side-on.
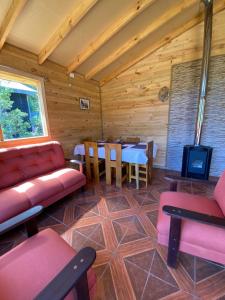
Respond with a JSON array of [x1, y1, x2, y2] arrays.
[[129, 141, 153, 187]]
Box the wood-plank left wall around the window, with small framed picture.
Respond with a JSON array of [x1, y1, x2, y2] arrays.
[[0, 45, 102, 155]]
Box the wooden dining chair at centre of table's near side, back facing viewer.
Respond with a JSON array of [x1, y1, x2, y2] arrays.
[[105, 144, 128, 187]]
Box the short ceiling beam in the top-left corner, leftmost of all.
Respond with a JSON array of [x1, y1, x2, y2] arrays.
[[0, 0, 27, 50]]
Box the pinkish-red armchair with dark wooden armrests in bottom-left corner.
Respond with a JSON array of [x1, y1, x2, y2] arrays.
[[0, 206, 96, 300]]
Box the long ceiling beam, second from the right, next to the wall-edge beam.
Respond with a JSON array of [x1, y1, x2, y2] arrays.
[[85, 0, 199, 80]]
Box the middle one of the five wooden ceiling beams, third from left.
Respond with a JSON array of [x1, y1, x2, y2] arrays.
[[67, 0, 156, 73]]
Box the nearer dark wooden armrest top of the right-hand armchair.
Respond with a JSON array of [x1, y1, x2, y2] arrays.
[[163, 205, 225, 229]]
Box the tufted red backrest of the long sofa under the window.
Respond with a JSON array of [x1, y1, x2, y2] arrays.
[[0, 142, 65, 189]]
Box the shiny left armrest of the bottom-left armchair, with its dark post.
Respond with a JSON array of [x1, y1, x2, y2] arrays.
[[0, 205, 44, 236]]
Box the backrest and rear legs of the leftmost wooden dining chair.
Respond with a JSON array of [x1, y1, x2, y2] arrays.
[[84, 141, 99, 183]]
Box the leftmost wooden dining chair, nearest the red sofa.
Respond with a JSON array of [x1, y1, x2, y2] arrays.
[[84, 141, 105, 183]]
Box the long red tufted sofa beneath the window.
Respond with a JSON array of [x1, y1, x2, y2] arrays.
[[0, 142, 86, 223]]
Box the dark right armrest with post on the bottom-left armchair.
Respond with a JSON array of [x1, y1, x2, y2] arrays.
[[35, 247, 96, 300]]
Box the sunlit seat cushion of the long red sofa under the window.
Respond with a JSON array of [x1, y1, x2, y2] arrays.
[[0, 168, 86, 218]]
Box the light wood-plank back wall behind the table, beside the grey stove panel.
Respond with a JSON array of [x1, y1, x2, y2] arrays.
[[101, 11, 225, 167]]
